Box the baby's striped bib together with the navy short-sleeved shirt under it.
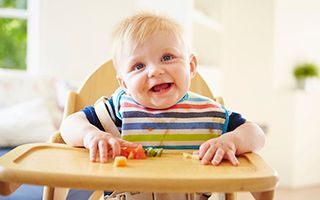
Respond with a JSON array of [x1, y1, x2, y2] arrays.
[[83, 90, 245, 149]]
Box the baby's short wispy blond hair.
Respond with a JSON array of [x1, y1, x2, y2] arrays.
[[113, 12, 189, 69]]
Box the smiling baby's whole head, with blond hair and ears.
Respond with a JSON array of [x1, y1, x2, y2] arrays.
[[113, 13, 197, 109]]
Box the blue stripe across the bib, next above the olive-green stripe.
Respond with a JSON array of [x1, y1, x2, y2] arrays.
[[122, 122, 224, 131]]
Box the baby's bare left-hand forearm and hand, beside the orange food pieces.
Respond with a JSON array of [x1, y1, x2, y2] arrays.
[[60, 112, 136, 162]]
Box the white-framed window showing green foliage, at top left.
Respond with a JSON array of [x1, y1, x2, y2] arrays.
[[0, 0, 29, 70]]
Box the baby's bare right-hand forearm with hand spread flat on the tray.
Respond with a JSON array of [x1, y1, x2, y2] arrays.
[[199, 122, 265, 165]]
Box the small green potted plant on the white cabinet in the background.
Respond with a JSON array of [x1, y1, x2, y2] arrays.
[[293, 62, 319, 89]]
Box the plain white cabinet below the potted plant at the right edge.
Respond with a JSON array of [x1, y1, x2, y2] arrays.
[[291, 92, 320, 187]]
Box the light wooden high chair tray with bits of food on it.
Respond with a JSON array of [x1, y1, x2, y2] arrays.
[[0, 143, 277, 194]]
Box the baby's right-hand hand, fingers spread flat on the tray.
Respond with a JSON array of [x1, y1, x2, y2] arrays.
[[199, 133, 239, 166]]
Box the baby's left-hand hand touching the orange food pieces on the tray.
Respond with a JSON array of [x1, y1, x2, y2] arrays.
[[83, 131, 137, 162]]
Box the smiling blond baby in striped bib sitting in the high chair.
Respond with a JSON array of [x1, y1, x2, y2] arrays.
[[61, 13, 265, 199]]
